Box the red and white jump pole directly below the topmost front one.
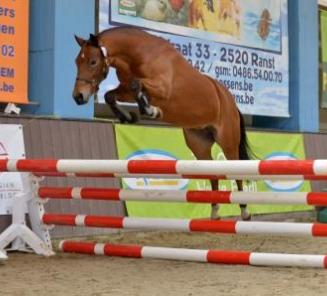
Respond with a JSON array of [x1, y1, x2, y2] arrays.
[[38, 187, 327, 206]]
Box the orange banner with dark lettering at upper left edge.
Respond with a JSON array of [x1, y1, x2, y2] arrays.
[[0, 0, 29, 103]]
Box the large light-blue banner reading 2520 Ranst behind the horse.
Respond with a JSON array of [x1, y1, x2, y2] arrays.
[[98, 0, 289, 117]]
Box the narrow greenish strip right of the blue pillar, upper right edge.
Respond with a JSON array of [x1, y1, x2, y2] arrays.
[[320, 10, 327, 108]]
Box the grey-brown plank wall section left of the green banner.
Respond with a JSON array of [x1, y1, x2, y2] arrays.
[[0, 117, 125, 237]]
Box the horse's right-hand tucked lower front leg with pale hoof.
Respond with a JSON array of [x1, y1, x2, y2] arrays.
[[130, 79, 162, 118]]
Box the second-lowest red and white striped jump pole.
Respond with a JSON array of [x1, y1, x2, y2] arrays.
[[42, 213, 327, 236]]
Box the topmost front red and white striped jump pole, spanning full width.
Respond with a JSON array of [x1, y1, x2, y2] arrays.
[[0, 159, 327, 177]]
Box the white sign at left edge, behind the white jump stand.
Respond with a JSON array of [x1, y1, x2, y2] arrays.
[[0, 124, 25, 215]]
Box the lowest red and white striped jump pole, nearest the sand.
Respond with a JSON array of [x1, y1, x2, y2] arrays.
[[59, 241, 327, 268]]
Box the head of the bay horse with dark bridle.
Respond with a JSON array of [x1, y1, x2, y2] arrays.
[[73, 34, 109, 105]]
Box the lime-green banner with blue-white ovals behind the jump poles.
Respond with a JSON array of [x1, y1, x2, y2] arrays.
[[115, 125, 311, 218]]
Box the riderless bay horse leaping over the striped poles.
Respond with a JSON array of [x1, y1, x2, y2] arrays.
[[73, 27, 251, 220]]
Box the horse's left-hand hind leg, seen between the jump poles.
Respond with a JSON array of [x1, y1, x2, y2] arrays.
[[183, 129, 219, 219]]
